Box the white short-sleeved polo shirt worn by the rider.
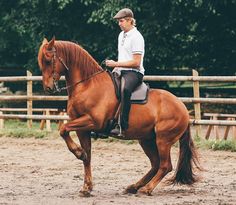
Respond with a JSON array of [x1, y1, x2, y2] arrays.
[[113, 27, 145, 75]]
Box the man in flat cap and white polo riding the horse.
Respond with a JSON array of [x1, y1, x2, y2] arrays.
[[106, 8, 144, 135]]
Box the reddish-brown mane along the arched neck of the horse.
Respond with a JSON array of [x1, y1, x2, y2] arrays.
[[55, 41, 102, 79]]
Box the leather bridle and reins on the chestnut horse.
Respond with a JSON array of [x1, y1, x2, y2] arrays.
[[47, 47, 106, 93]]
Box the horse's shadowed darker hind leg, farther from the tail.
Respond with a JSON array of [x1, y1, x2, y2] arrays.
[[125, 138, 159, 194]]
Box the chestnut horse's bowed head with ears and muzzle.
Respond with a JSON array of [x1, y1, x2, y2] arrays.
[[38, 37, 67, 93]]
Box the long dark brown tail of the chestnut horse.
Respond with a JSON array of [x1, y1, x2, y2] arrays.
[[170, 125, 201, 185]]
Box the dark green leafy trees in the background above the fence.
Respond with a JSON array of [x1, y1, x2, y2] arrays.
[[0, 0, 236, 75]]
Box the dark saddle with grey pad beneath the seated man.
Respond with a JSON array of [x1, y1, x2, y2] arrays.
[[107, 71, 149, 104]]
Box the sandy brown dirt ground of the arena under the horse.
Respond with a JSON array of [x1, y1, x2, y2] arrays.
[[0, 137, 236, 205]]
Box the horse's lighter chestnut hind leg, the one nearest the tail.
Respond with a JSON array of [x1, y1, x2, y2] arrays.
[[138, 135, 172, 195]]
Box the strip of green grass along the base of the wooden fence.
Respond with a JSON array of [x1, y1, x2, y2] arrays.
[[0, 120, 236, 152]]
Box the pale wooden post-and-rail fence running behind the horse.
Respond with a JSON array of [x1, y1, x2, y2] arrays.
[[0, 70, 236, 139]]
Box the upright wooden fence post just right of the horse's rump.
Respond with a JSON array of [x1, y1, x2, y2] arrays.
[[192, 69, 201, 136]]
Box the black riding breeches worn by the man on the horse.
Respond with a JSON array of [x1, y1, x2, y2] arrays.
[[120, 70, 143, 130]]
